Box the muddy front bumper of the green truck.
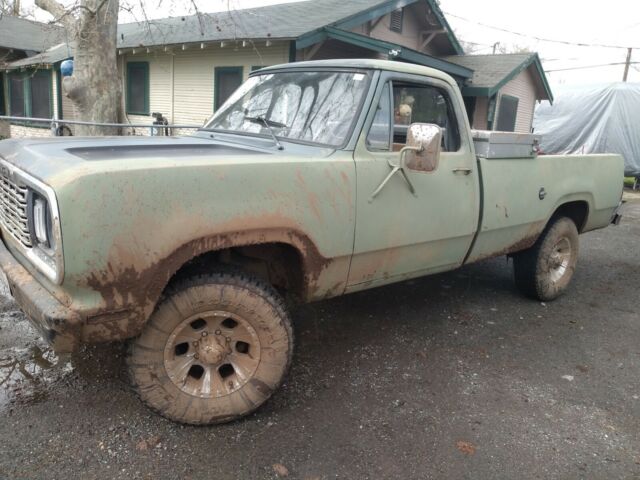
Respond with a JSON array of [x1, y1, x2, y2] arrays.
[[0, 240, 82, 353]]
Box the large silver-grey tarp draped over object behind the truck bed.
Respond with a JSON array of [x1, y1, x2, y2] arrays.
[[533, 83, 640, 176]]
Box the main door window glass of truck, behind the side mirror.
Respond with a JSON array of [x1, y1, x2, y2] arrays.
[[393, 82, 460, 152]]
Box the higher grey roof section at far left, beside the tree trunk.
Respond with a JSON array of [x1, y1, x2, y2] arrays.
[[0, 15, 64, 52]]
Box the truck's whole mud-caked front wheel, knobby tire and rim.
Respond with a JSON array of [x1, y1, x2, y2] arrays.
[[128, 272, 293, 425]]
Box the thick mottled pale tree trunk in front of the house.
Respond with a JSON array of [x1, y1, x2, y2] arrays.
[[36, 0, 122, 135]]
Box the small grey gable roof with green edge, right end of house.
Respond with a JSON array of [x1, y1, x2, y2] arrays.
[[445, 53, 553, 102]]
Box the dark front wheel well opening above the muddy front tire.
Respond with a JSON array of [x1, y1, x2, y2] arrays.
[[169, 242, 304, 298]]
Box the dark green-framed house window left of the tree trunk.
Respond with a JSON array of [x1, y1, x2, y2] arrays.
[[8, 70, 53, 118]]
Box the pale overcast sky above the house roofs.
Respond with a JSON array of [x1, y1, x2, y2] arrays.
[[22, 0, 640, 87]]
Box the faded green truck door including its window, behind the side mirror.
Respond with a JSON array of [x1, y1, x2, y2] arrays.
[[347, 72, 479, 291]]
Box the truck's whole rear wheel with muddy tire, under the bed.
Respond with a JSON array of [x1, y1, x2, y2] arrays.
[[513, 217, 579, 301]]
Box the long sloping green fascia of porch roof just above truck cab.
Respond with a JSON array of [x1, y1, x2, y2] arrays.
[[296, 27, 473, 79]]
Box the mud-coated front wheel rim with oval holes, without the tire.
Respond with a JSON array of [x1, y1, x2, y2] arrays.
[[164, 310, 260, 398]]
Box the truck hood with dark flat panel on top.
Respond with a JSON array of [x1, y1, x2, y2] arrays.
[[0, 136, 292, 186]]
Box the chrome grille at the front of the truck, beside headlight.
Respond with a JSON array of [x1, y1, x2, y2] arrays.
[[0, 169, 32, 248]]
